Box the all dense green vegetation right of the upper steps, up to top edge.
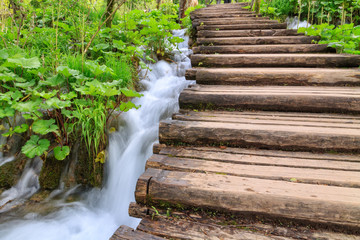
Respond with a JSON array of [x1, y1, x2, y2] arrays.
[[255, 0, 360, 54]]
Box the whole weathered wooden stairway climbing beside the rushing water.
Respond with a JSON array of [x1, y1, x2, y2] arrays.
[[112, 4, 360, 239]]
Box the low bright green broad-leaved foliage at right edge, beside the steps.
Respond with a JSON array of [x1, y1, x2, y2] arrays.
[[299, 23, 360, 54]]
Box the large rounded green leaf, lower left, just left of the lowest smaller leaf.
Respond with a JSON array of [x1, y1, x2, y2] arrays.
[[21, 135, 50, 158]]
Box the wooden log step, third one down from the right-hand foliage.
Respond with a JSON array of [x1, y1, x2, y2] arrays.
[[179, 85, 360, 113]]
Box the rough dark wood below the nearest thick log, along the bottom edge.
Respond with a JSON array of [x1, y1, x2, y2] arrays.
[[129, 203, 360, 240]]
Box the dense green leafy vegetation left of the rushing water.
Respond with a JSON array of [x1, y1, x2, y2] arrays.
[[0, 0, 182, 186]]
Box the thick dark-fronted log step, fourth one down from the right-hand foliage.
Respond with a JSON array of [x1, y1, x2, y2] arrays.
[[160, 116, 360, 152]]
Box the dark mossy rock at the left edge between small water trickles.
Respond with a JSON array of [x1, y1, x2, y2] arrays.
[[0, 154, 27, 189]]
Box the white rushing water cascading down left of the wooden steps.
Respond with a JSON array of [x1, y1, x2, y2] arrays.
[[0, 30, 191, 240]]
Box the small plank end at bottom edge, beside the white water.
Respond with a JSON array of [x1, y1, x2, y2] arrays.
[[110, 225, 165, 240]]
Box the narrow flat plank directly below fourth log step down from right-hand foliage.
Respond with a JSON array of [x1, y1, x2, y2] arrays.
[[158, 144, 360, 171]]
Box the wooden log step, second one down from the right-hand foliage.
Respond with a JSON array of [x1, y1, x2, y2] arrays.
[[186, 68, 360, 86]]
